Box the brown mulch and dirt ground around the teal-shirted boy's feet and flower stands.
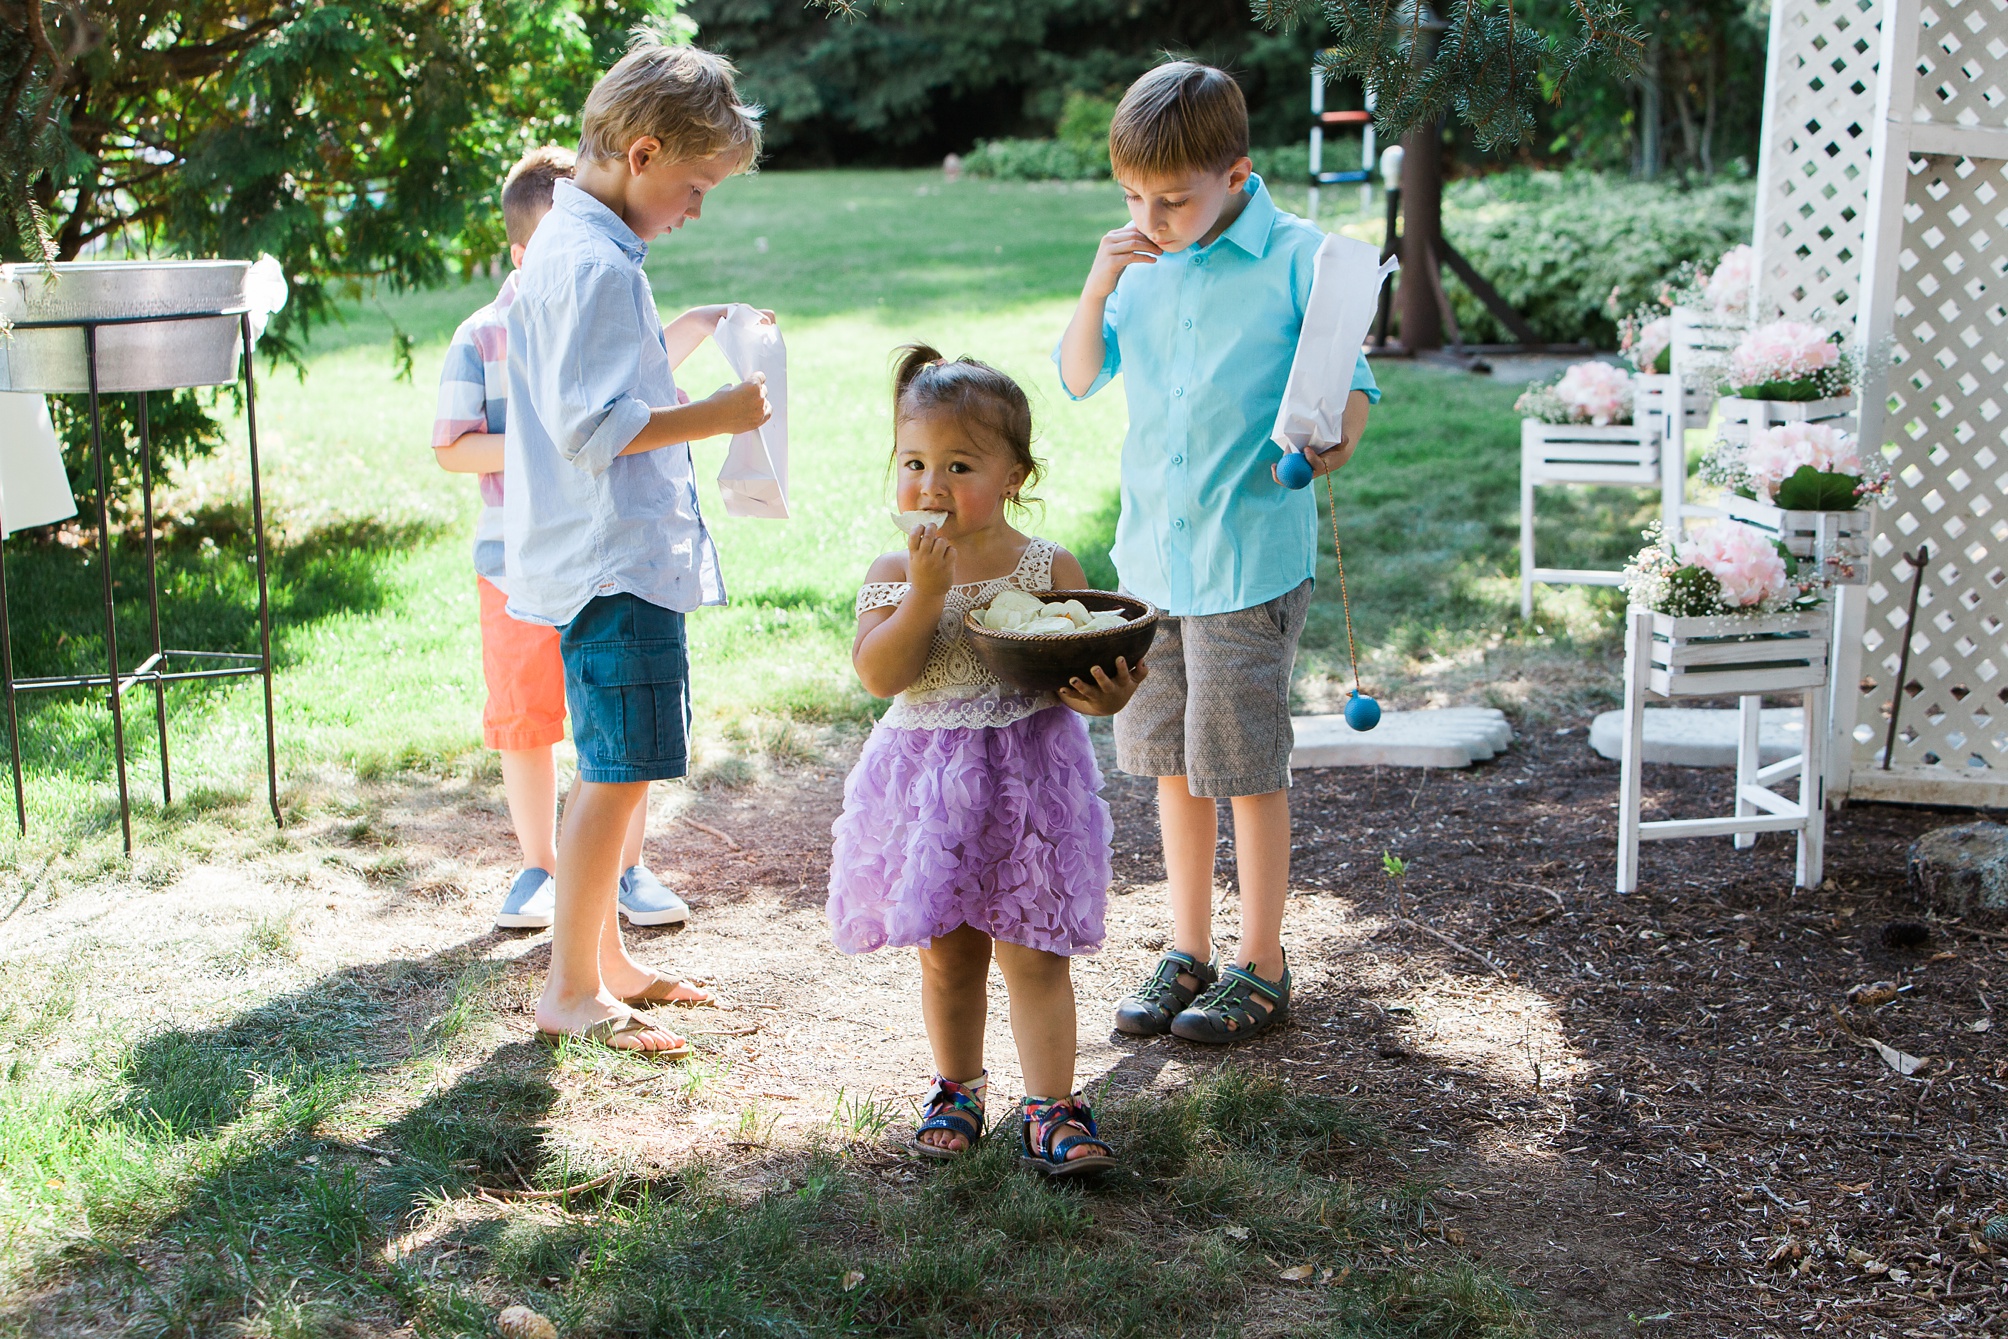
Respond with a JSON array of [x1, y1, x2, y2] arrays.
[[661, 727, 2008, 1335]]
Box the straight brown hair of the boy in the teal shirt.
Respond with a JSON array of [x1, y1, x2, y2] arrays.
[[1108, 60, 1249, 177]]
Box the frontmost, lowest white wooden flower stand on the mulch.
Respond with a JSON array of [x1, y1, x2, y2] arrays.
[[1616, 606, 1831, 893]]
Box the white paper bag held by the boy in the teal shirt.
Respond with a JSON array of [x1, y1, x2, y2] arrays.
[[1269, 233, 1402, 452]]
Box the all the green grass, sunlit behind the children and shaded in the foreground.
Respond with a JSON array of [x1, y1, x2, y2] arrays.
[[0, 173, 1639, 1335]]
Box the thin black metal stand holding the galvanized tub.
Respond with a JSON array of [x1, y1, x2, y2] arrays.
[[0, 311, 285, 855]]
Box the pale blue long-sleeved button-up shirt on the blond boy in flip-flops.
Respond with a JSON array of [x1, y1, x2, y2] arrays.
[[502, 181, 725, 626]]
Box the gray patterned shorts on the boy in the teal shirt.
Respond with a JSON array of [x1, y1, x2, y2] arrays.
[[1116, 582, 1311, 799]]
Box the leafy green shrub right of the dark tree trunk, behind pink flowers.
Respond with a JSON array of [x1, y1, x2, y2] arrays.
[[1444, 171, 1755, 347]]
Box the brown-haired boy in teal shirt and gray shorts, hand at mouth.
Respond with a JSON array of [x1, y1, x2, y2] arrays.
[[1054, 60, 1379, 1042]]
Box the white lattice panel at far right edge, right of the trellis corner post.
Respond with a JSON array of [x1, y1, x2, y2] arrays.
[[1835, 0, 2008, 805]]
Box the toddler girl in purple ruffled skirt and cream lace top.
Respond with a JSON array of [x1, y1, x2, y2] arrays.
[[829, 345, 1145, 1176]]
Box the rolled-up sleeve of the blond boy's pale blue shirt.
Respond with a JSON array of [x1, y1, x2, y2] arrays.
[[526, 265, 657, 476]]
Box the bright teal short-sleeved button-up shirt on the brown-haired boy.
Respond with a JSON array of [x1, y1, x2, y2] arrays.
[[1052, 177, 1379, 616]]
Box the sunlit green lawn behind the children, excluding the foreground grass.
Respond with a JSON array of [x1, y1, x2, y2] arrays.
[[0, 162, 1633, 843]]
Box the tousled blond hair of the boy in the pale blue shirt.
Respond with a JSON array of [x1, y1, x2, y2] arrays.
[[578, 38, 759, 167]]
